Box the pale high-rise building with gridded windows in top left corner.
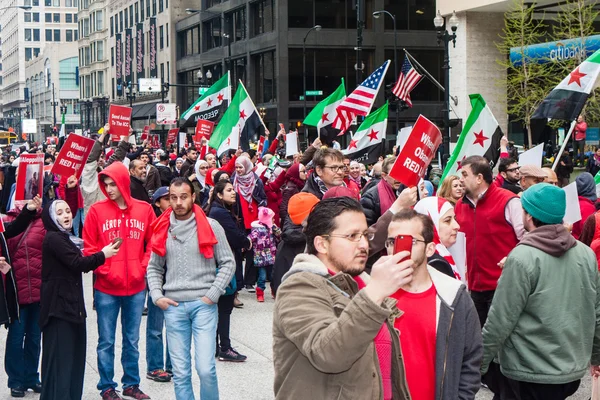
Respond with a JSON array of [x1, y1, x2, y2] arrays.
[[0, 0, 79, 136]]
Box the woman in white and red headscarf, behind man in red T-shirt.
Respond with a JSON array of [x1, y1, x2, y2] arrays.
[[415, 197, 464, 280]]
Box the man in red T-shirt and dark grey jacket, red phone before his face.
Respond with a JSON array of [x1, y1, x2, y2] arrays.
[[386, 209, 483, 400]]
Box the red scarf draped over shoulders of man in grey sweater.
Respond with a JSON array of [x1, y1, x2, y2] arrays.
[[150, 204, 218, 258]]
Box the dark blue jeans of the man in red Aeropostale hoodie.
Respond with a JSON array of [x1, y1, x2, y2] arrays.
[[94, 290, 146, 393]]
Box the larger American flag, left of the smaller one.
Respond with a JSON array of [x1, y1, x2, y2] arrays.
[[332, 60, 390, 135]]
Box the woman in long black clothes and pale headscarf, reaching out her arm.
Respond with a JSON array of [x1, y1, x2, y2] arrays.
[[39, 200, 121, 400]]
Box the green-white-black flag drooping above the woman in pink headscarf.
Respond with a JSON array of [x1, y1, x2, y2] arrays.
[[208, 81, 263, 157]]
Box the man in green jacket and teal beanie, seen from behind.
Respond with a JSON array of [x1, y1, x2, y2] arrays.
[[481, 183, 600, 400]]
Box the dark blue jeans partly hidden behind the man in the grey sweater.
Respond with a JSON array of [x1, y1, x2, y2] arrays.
[[146, 295, 173, 372]]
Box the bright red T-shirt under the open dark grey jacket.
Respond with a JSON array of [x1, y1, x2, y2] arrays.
[[392, 284, 436, 400]]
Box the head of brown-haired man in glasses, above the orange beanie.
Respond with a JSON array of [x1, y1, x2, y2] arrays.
[[302, 148, 345, 200]]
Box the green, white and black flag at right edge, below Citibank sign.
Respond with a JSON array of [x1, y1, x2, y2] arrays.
[[531, 50, 600, 121]]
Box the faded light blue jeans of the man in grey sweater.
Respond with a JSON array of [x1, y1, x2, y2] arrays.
[[164, 300, 219, 400]]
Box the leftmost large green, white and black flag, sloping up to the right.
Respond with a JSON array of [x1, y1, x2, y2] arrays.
[[179, 71, 231, 128]]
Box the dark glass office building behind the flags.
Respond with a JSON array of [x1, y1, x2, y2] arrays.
[[176, 0, 443, 148]]
